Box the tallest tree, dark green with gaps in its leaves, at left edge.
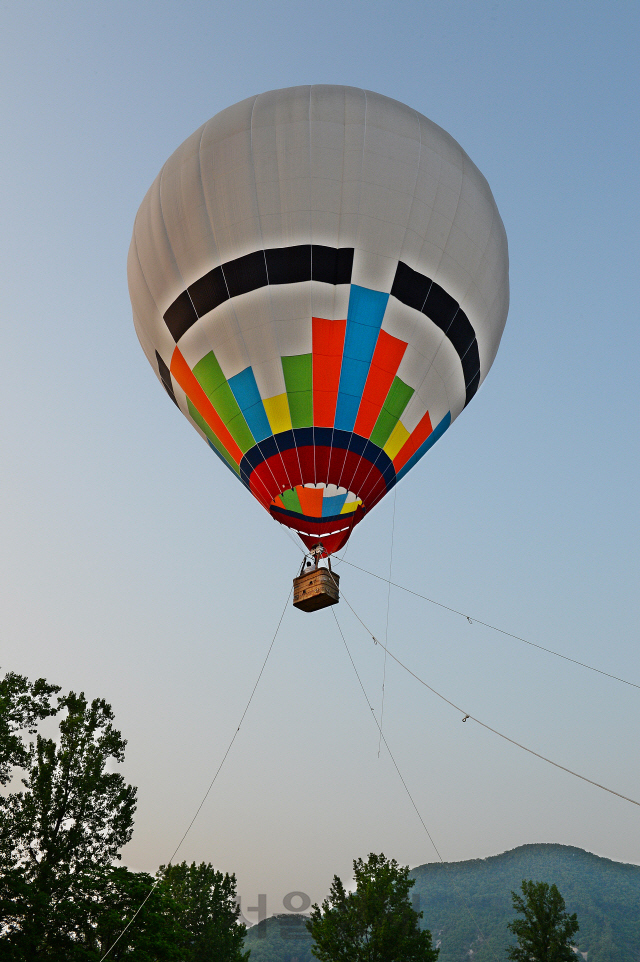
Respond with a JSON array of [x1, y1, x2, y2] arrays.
[[0, 674, 136, 959]]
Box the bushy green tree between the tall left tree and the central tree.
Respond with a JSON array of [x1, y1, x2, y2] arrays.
[[158, 862, 250, 962]]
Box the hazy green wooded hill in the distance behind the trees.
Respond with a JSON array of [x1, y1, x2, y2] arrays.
[[245, 845, 640, 962]]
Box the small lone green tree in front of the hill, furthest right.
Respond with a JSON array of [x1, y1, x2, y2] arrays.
[[507, 879, 580, 962]]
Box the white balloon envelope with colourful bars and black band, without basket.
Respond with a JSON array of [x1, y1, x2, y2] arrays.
[[128, 85, 509, 568]]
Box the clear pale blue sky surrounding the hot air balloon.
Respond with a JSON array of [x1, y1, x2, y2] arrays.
[[0, 0, 640, 911]]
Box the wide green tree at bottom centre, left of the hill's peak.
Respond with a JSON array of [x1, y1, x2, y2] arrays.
[[307, 854, 439, 962]]
